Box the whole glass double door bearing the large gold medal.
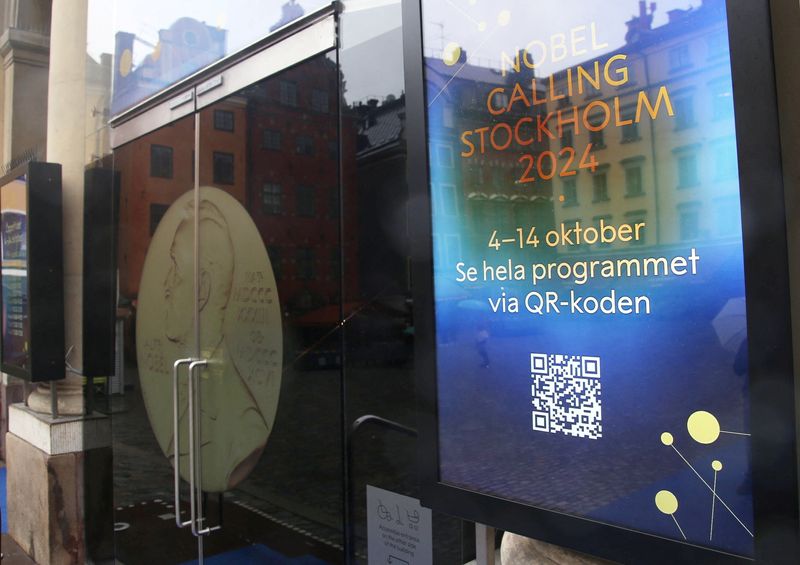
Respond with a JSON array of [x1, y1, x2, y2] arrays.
[[110, 22, 344, 565]]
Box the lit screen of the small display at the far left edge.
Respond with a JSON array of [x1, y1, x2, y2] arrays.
[[0, 177, 30, 371]]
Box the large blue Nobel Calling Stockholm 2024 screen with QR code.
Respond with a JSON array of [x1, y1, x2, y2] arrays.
[[421, 0, 754, 556]]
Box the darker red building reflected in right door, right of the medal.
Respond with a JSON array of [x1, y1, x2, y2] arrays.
[[246, 57, 357, 311]]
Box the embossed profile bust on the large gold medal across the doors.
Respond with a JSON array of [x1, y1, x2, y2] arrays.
[[164, 200, 270, 491]]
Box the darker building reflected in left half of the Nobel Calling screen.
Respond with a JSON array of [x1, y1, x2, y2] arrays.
[[426, 52, 554, 264]]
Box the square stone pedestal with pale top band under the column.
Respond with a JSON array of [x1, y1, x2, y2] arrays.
[[3, 404, 114, 565]]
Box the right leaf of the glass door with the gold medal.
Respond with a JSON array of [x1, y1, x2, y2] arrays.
[[195, 54, 343, 563]]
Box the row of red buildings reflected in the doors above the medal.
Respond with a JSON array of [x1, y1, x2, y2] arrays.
[[115, 53, 357, 318]]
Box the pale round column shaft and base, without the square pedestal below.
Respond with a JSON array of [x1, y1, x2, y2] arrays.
[[28, 0, 88, 415]]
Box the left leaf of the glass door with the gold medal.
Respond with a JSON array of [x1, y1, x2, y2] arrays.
[[110, 109, 211, 563]]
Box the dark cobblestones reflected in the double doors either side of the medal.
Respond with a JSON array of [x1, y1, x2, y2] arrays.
[[105, 362, 342, 545]]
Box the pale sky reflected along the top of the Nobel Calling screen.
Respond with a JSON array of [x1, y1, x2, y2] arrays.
[[423, 0, 700, 76]]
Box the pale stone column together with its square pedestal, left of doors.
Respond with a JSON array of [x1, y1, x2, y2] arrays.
[[4, 0, 113, 565]]
